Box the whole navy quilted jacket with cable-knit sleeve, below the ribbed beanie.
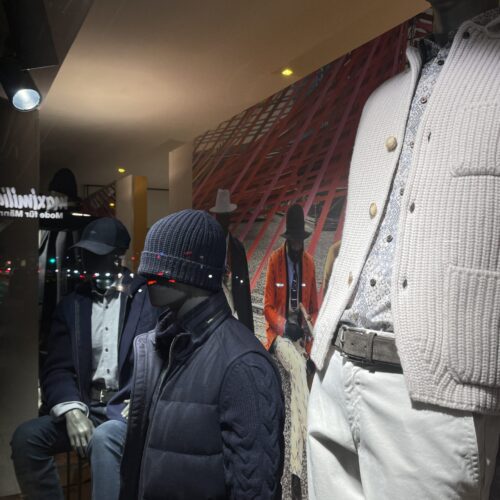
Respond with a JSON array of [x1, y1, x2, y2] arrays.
[[120, 293, 284, 500]]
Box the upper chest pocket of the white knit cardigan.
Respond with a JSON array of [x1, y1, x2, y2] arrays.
[[451, 101, 500, 177]]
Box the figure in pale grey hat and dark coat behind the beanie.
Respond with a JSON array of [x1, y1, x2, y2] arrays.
[[210, 189, 254, 332]]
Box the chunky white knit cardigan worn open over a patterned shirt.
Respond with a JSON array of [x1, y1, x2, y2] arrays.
[[312, 17, 500, 413]]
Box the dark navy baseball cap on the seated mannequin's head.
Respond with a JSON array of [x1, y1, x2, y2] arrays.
[[73, 217, 130, 255]]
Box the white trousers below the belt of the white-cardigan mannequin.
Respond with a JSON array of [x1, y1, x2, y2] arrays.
[[307, 350, 500, 500]]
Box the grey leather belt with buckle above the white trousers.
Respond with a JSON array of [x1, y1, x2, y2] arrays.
[[334, 325, 401, 369]]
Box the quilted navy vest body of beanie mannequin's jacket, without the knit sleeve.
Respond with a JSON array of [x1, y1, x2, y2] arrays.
[[120, 293, 279, 500]]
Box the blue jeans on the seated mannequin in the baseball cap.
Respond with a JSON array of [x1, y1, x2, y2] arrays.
[[11, 416, 127, 500]]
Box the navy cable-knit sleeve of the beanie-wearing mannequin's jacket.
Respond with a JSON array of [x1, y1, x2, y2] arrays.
[[220, 353, 284, 500]]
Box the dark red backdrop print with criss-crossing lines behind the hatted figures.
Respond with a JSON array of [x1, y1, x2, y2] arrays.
[[193, 10, 431, 498]]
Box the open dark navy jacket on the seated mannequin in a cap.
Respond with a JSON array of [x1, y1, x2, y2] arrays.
[[41, 273, 158, 420]]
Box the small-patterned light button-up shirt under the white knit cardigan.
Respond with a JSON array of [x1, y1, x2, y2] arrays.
[[341, 9, 499, 332]]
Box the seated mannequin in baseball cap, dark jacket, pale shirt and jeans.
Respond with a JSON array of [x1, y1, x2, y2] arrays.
[[11, 218, 158, 500]]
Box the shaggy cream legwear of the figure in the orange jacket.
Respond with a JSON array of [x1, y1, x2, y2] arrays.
[[274, 337, 309, 477]]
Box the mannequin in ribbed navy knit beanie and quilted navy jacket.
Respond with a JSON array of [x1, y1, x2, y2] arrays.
[[120, 210, 284, 500]]
